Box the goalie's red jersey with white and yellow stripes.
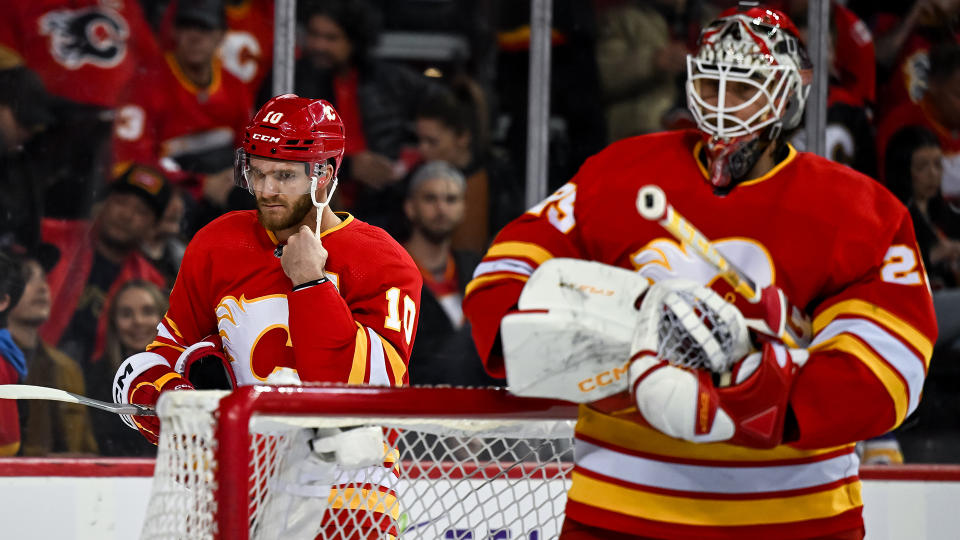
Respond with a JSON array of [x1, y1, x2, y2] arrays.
[[464, 131, 936, 540]]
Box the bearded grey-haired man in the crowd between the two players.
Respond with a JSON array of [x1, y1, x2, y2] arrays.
[[403, 161, 497, 386]]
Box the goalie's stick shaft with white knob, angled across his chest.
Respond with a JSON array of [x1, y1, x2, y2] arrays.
[[637, 184, 813, 347]]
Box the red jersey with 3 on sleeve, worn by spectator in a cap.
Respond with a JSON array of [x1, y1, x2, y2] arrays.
[[113, 53, 253, 186]]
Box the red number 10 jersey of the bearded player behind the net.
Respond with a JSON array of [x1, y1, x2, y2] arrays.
[[147, 210, 422, 386]]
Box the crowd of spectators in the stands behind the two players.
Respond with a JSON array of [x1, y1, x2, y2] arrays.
[[0, 0, 960, 461]]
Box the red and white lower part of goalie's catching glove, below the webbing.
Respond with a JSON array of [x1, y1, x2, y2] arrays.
[[629, 342, 807, 448]]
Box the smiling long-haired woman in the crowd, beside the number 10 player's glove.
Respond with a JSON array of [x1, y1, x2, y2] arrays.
[[86, 279, 167, 456]]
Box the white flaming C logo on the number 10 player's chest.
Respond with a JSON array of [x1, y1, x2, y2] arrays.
[[216, 294, 295, 385]]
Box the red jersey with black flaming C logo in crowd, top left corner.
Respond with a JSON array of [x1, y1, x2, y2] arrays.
[[0, 0, 159, 108]]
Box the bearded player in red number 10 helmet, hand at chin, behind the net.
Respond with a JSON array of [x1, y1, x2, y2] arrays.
[[113, 94, 422, 534]]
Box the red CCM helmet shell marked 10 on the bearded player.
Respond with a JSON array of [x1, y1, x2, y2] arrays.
[[236, 94, 345, 193]]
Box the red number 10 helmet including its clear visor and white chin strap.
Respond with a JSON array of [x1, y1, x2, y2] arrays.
[[234, 94, 345, 216]]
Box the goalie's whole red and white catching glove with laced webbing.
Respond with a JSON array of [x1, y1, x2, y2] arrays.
[[629, 280, 807, 448]]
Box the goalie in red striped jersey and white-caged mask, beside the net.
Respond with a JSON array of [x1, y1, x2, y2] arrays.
[[464, 7, 936, 540]]
